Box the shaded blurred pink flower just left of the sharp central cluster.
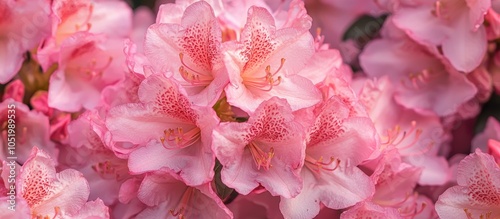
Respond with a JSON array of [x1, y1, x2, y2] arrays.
[[63, 111, 131, 206]]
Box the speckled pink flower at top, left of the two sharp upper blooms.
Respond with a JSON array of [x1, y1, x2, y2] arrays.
[[144, 1, 229, 106]]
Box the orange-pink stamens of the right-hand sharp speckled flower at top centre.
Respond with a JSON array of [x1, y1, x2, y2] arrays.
[[243, 58, 286, 91]]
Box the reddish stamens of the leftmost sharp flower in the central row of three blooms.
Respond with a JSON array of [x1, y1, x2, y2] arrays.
[[160, 127, 201, 149]]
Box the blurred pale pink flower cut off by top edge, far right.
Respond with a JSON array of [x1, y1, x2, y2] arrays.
[[394, 0, 491, 73]]
